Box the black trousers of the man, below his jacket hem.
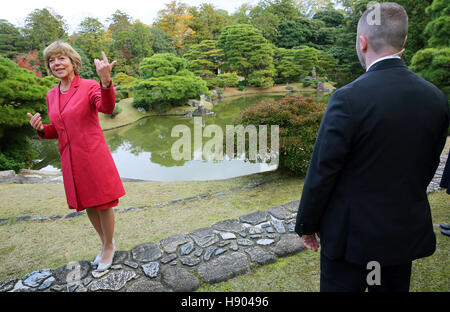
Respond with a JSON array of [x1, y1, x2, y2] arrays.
[[320, 253, 412, 292]]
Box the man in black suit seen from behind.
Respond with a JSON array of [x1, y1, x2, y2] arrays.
[[295, 2, 450, 291]]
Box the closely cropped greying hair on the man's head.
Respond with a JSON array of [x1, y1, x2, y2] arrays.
[[357, 2, 408, 53]]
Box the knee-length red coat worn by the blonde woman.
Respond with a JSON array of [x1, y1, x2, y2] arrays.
[[38, 75, 125, 210]]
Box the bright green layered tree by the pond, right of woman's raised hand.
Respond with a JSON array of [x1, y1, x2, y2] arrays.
[[133, 53, 210, 111]]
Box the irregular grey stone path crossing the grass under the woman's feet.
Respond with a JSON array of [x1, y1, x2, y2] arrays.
[[0, 155, 447, 292]]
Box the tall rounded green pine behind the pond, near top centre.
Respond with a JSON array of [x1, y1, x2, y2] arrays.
[[218, 24, 276, 87]]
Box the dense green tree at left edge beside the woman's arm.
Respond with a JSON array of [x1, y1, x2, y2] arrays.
[[0, 57, 56, 171]]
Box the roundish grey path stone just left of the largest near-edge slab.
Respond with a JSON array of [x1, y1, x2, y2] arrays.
[[161, 266, 200, 292]]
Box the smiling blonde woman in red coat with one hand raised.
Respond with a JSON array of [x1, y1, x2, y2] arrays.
[[28, 41, 125, 271]]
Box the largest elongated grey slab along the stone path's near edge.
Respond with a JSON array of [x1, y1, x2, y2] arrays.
[[198, 252, 250, 284]]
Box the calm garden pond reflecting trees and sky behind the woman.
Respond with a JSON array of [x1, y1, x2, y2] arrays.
[[32, 92, 327, 181]]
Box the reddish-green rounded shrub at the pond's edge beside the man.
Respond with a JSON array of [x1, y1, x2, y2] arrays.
[[237, 97, 326, 176]]
